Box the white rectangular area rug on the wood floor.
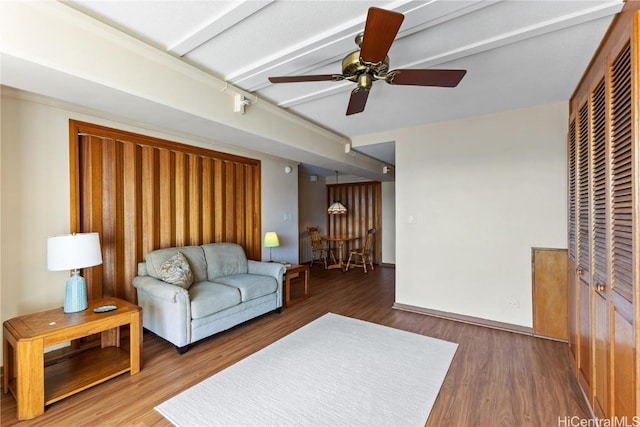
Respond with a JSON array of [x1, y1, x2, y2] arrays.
[[156, 313, 458, 427]]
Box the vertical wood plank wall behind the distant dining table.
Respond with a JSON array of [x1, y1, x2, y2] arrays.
[[327, 181, 382, 264]]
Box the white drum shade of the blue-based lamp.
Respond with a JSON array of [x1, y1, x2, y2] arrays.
[[47, 233, 102, 271]]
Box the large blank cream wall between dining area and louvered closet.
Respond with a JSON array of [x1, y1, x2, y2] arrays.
[[396, 103, 568, 327]]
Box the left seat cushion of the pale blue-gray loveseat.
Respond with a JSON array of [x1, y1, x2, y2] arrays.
[[189, 281, 240, 319]]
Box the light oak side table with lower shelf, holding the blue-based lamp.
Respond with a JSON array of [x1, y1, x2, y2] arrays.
[[2, 298, 142, 420]]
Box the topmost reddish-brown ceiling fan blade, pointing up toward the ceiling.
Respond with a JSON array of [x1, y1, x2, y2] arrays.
[[360, 7, 404, 64]]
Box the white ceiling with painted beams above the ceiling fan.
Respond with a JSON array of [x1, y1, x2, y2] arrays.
[[6, 0, 622, 174]]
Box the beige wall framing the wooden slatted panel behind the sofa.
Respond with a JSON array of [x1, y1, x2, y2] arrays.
[[0, 87, 298, 362]]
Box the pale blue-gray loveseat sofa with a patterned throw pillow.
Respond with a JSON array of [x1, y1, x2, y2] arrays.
[[133, 243, 285, 354]]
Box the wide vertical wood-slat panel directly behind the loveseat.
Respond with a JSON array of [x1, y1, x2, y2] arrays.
[[69, 120, 261, 302]]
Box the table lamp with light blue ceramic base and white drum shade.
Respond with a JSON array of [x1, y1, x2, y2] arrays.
[[47, 233, 102, 313]]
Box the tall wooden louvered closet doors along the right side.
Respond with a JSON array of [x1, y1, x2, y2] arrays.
[[567, 2, 640, 419]]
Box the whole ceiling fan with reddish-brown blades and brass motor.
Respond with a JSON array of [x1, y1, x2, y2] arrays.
[[269, 7, 467, 116]]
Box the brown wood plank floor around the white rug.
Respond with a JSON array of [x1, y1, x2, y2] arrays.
[[0, 266, 589, 427]]
